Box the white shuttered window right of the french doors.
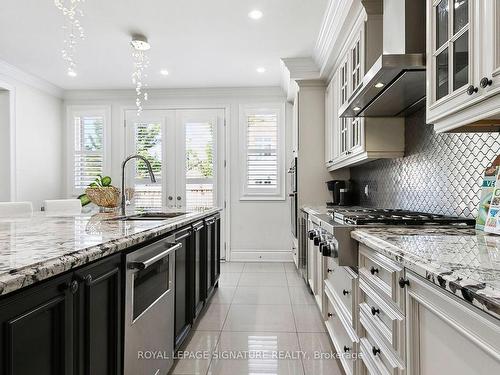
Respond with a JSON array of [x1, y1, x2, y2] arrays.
[[241, 106, 284, 199]]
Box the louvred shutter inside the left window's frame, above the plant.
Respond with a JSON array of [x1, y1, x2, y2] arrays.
[[73, 116, 104, 192]]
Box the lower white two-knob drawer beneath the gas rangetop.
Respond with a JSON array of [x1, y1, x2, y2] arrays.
[[325, 298, 358, 375]]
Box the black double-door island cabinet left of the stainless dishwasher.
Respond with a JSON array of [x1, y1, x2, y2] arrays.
[[0, 255, 122, 375]]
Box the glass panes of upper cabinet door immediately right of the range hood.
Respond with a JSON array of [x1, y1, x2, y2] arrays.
[[433, 0, 471, 101]]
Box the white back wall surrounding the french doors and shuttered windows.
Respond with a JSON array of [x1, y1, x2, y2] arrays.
[[65, 87, 291, 260]]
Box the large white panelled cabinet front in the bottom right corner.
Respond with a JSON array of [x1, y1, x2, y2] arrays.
[[406, 271, 500, 375]]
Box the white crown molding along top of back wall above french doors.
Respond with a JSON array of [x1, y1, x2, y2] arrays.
[[63, 86, 284, 101]]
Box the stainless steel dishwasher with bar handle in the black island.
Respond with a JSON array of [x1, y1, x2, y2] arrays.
[[124, 236, 182, 375]]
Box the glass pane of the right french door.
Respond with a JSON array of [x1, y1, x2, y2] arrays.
[[185, 122, 214, 210]]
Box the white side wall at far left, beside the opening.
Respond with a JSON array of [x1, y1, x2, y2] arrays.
[[0, 61, 63, 209]]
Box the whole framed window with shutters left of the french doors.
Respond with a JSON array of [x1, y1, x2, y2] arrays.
[[68, 108, 108, 195]]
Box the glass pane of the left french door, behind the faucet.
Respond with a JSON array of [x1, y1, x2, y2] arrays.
[[134, 123, 162, 208]]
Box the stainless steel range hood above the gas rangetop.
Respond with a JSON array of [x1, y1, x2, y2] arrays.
[[339, 0, 426, 117]]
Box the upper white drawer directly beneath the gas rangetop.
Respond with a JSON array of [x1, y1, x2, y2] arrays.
[[325, 267, 357, 322]]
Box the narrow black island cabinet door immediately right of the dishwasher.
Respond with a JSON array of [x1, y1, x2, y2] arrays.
[[174, 228, 194, 349]]
